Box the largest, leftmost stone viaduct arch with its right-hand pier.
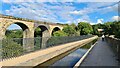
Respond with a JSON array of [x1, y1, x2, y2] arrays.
[[1, 20, 34, 51]]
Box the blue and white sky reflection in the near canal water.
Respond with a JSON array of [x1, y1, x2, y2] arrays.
[[51, 48, 87, 67]]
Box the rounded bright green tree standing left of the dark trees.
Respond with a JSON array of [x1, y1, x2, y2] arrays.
[[78, 22, 93, 35]]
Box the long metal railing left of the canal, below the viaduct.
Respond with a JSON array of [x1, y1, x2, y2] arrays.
[[0, 35, 93, 60]]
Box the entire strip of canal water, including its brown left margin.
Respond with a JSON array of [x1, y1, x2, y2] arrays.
[[37, 39, 97, 68]]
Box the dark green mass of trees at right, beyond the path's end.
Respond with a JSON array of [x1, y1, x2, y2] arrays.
[[92, 21, 120, 38]]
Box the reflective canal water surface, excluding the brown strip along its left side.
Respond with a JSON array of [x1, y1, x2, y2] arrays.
[[51, 39, 97, 68]]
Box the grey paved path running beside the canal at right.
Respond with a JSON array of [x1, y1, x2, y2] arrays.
[[81, 39, 118, 66]]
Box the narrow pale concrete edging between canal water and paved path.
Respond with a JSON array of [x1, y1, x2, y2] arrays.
[[73, 38, 98, 68]]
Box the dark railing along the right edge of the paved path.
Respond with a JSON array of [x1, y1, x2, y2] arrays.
[[106, 37, 120, 62]]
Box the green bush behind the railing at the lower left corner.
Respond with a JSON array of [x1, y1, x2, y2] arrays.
[[2, 39, 23, 58]]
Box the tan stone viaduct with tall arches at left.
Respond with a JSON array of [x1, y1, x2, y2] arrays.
[[0, 15, 63, 51]]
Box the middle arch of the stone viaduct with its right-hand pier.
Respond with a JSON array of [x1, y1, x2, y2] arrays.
[[34, 25, 50, 48]]
